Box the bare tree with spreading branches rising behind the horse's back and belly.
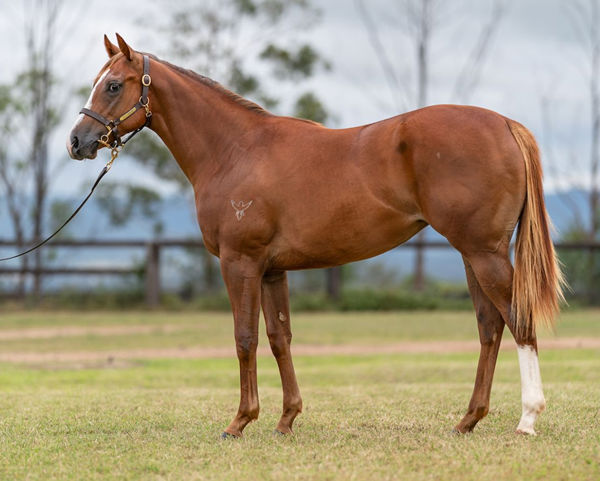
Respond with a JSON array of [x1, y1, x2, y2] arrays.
[[355, 0, 504, 291]]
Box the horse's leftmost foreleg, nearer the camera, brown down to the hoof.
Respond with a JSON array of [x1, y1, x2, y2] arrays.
[[221, 260, 262, 437]]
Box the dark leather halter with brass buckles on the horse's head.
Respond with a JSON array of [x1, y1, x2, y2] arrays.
[[79, 55, 152, 160]]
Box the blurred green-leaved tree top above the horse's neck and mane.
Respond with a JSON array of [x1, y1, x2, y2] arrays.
[[156, 0, 328, 109]]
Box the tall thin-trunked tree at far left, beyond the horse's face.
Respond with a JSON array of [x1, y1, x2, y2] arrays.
[[0, 0, 62, 297]]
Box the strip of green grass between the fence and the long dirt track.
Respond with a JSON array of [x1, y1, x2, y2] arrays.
[[0, 310, 600, 352]]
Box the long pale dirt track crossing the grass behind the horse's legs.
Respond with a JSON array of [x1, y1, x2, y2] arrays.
[[0, 336, 600, 367]]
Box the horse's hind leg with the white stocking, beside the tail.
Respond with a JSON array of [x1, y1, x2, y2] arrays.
[[466, 248, 546, 434]]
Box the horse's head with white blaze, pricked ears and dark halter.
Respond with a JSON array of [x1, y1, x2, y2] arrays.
[[67, 34, 151, 160]]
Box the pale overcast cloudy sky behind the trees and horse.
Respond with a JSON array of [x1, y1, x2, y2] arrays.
[[0, 0, 589, 195]]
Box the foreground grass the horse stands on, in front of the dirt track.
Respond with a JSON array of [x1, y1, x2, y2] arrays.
[[0, 351, 600, 480]]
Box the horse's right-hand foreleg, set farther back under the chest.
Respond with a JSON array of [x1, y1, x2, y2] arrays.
[[261, 272, 302, 434]]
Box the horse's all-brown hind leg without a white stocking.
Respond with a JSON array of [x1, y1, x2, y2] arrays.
[[454, 257, 504, 433]]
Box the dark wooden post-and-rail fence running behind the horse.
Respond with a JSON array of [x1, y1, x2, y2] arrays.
[[0, 239, 600, 306]]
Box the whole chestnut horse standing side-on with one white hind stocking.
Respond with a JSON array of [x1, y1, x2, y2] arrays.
[[67, 36, 562, 437]]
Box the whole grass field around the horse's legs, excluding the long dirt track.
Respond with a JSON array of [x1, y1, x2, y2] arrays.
[[0, 310, 600, 480]]
